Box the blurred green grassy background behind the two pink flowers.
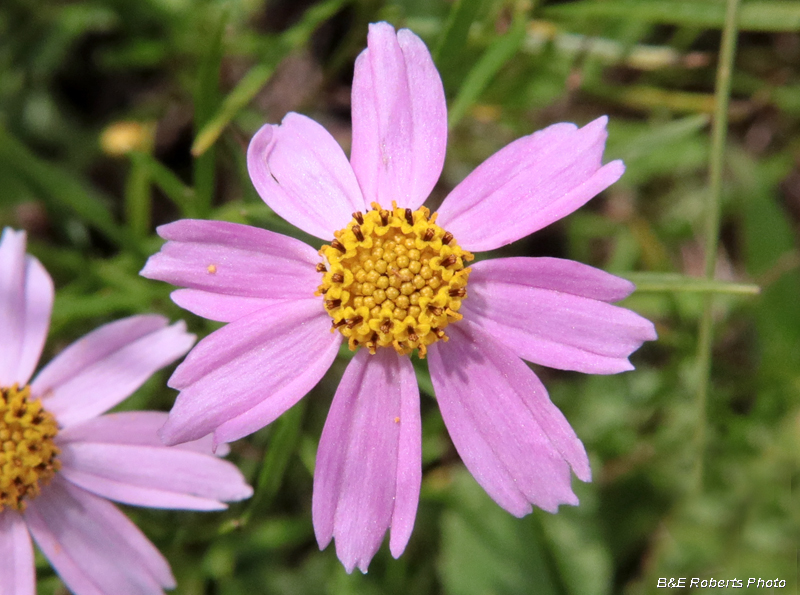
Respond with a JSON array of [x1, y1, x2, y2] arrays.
[[0, 0, 800, 595]]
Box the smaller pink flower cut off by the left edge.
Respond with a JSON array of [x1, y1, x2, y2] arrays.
[[0, 229, 252, 595]]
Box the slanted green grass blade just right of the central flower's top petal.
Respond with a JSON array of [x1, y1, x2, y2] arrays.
[[448, 13, 526, 128]]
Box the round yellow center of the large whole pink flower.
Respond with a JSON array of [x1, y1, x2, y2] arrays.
[[316, 203, 473, 358]]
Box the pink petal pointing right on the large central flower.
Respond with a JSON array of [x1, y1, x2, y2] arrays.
[[461, 258, 656, 374]]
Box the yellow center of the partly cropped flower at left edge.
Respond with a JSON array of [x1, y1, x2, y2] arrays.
[[0, 384, 61, 511]]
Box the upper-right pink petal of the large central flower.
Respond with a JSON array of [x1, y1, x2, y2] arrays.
[[436, 116, 625, 252]]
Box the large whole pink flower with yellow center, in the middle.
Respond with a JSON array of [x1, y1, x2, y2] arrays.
[[142, 23, 656, 572]]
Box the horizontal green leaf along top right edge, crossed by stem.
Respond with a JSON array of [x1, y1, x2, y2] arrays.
[[542, 0, 800, 32]]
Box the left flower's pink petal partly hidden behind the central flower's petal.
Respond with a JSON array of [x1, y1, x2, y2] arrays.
[[56, 411, 229, 456]]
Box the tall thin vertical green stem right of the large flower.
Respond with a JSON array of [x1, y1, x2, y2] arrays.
[[694, 0, 739, 491]]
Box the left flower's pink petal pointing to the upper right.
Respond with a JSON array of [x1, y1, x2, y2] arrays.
[[31, 315, 195, 427]]
